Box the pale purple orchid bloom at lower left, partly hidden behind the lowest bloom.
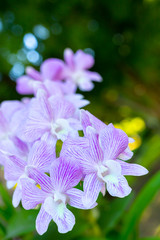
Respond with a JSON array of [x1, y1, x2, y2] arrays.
[[4, 141, 55, 207]]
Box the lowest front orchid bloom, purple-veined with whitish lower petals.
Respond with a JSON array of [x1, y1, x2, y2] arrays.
[[22, 158, 94, 235]]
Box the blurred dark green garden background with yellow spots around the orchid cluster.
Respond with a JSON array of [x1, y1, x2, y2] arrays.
[[0, 0, 160, 240]]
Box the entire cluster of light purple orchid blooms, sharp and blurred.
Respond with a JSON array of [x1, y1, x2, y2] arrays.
[[0, 49, 148, 235]]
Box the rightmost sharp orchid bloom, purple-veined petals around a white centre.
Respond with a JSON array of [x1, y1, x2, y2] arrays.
[[62, 124, 148, 207]]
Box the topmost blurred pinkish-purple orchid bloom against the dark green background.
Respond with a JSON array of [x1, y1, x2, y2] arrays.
[[64, 48, 102, 91]]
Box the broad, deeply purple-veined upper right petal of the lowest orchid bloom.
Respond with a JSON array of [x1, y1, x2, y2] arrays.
[[50, 157, 82, 192]]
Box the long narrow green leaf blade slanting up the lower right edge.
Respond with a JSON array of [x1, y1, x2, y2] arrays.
[[121, 171, 160, 240]]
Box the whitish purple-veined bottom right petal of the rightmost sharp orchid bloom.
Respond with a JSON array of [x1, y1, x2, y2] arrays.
[[107, 175, 132, 198]]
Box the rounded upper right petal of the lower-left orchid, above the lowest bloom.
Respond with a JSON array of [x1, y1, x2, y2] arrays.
[[28, 141, 56, 172]]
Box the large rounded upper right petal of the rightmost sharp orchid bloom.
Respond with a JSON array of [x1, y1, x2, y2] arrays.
[[99, 124, 128, 160]]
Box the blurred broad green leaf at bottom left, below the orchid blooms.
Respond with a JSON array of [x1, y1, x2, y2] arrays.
[[5, 209, 38, 239]]
